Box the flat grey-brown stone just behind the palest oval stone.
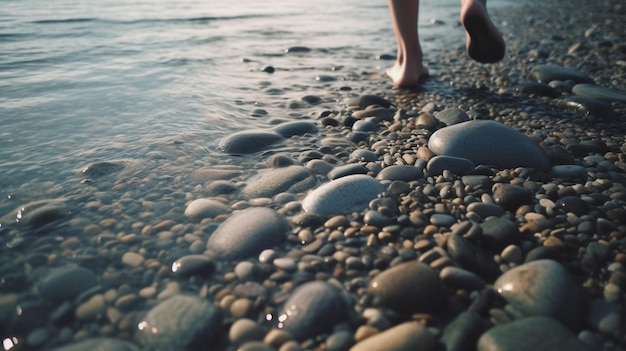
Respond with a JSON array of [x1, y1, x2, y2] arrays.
[[242, 166, 317, 198]]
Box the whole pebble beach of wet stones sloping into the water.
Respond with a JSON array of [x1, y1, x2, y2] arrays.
[[0, 0, 626, 351]]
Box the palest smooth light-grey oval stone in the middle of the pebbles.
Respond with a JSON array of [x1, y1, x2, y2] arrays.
[[302, 174, 385, 216]]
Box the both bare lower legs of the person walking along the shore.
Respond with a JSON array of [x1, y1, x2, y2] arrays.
[[385, 0, 505, 86]]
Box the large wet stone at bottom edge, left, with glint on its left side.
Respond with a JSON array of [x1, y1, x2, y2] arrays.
[[136, 295, 221, 351]]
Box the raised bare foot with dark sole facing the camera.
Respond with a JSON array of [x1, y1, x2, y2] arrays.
[[461, 0, 505, 63]]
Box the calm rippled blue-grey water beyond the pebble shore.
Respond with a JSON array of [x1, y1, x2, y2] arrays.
[[0, 0, 478, 195]]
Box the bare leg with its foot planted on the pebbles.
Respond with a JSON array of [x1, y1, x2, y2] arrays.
[[385, 0, 428, 86]]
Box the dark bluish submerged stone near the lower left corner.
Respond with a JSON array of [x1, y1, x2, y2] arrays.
[[38, 266, 98, 303]]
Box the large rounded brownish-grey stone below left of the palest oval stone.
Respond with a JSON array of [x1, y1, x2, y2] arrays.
[[207, 207, 290, 260]]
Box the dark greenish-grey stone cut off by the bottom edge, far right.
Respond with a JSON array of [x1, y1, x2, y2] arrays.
[[477, 317, 591, 351]]
